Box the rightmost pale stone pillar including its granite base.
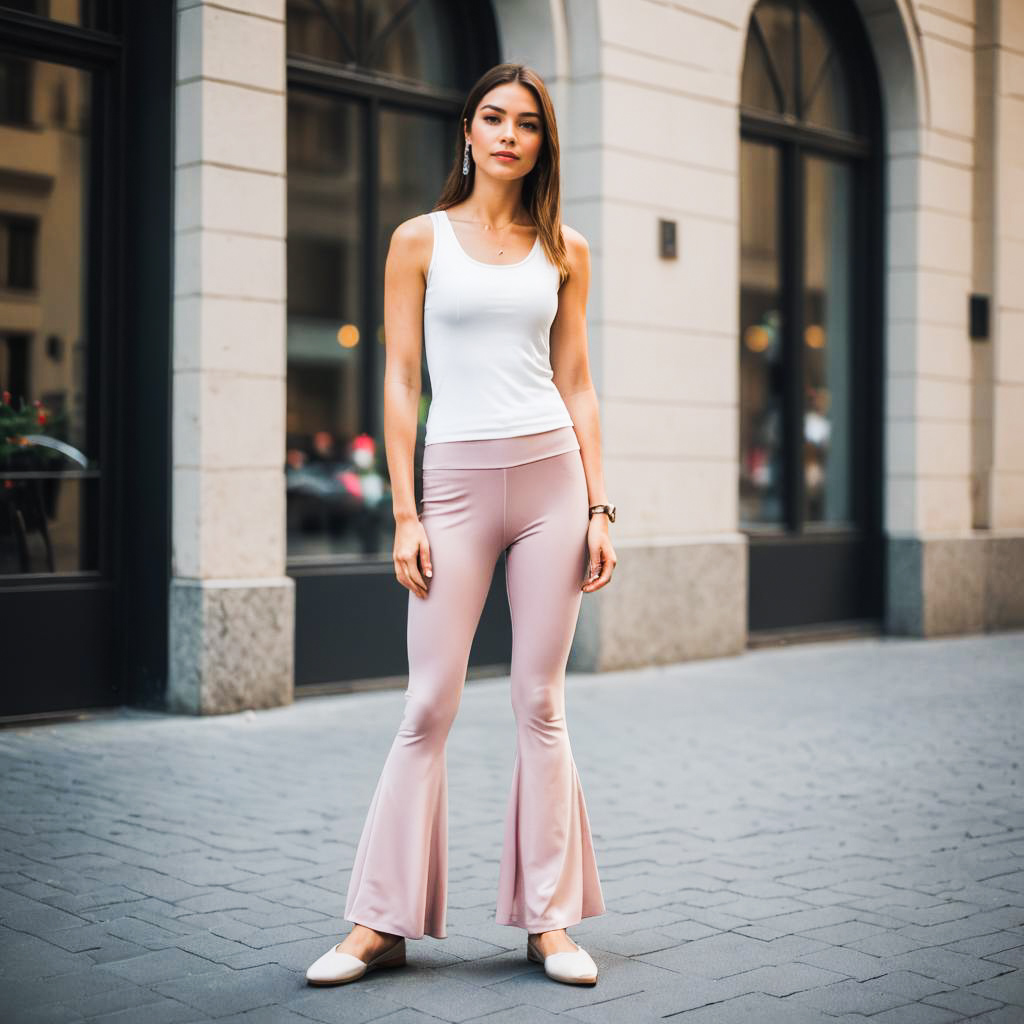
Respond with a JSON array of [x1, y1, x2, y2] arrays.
[[874, 4, 983, 635]]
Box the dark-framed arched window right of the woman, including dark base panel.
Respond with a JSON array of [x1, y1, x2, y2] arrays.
[[739, 0, 882, 631]]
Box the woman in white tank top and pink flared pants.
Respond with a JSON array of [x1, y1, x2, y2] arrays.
[[306, 63, 615, 984]]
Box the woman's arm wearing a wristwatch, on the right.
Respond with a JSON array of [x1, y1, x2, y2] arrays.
[[551, 225, 615, 593]]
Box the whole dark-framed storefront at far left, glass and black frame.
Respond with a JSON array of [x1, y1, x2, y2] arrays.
[[0, 0, 174, 716]]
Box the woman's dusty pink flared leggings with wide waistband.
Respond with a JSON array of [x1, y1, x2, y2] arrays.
[[345, 427, 605, 939]]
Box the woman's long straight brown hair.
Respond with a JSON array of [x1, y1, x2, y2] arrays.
[[434, 63, 569, 288]]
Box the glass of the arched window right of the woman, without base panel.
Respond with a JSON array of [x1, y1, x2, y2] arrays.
[[739, 0, 866, 530]]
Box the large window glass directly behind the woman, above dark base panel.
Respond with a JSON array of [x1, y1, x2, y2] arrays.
[[285, 0, 494, 565]]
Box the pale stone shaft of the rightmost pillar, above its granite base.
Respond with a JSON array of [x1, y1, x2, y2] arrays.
[[883, 0, 974, 536]]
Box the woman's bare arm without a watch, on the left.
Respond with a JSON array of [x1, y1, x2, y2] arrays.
[[384, 215, 433, 597]]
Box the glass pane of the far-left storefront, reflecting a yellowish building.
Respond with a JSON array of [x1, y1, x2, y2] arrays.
[[0, 56, 99, 575]]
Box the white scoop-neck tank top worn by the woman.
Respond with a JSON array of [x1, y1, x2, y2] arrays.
[[423, 210, 572, 444]]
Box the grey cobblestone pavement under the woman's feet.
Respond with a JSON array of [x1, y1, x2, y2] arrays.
[[0, 632, 1024, 1024]]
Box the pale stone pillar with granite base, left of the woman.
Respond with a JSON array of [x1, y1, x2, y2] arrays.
[[165, 0, 294, 714]]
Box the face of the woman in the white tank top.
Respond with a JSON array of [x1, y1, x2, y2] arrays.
[[468, 82, 544, 178]]
